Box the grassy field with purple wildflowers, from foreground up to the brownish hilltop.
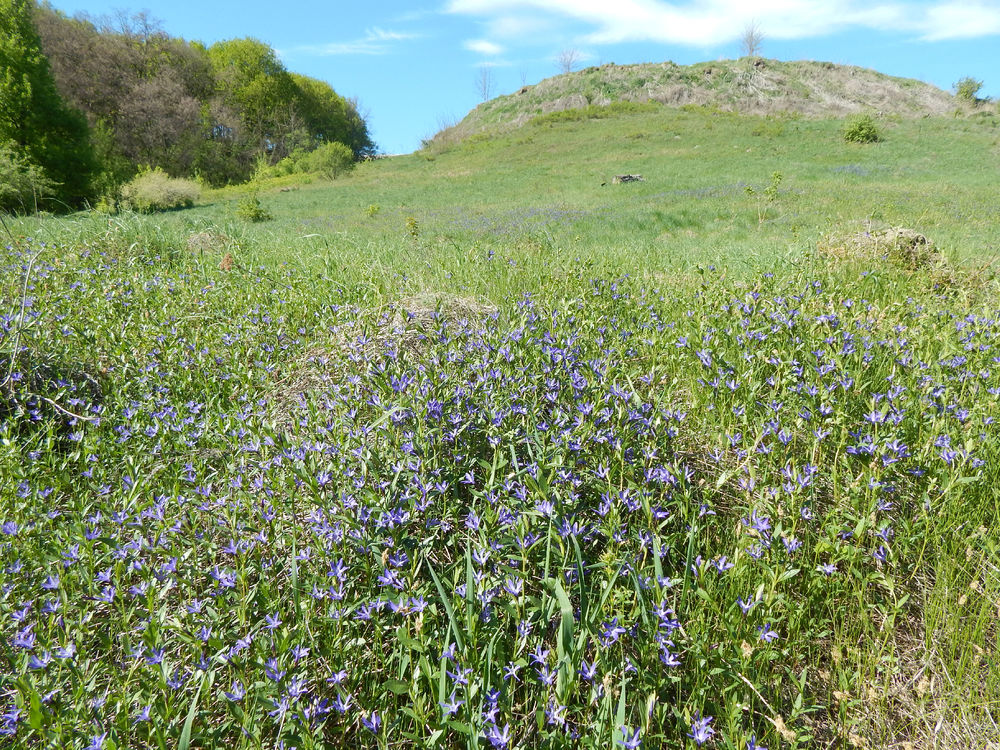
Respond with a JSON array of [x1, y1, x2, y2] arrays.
[[0, 108, 1000, 750]]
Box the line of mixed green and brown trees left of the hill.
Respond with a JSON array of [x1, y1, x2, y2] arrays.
[[0, 0, 375, 210]]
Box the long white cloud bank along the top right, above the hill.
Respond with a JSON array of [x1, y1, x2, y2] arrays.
[[446, 0, 1000, 46]]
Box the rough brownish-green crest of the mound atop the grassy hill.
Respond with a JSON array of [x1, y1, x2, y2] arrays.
[[444, 58, 959, 138]]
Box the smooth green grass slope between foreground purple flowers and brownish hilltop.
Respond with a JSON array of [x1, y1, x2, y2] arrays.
[[21, 105, 1000, 295]]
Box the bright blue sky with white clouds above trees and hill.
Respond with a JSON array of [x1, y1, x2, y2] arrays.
[[53, 0, 1000, 153]]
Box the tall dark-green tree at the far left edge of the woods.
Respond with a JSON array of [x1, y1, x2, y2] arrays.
[[0, 0, 95, 205]]
